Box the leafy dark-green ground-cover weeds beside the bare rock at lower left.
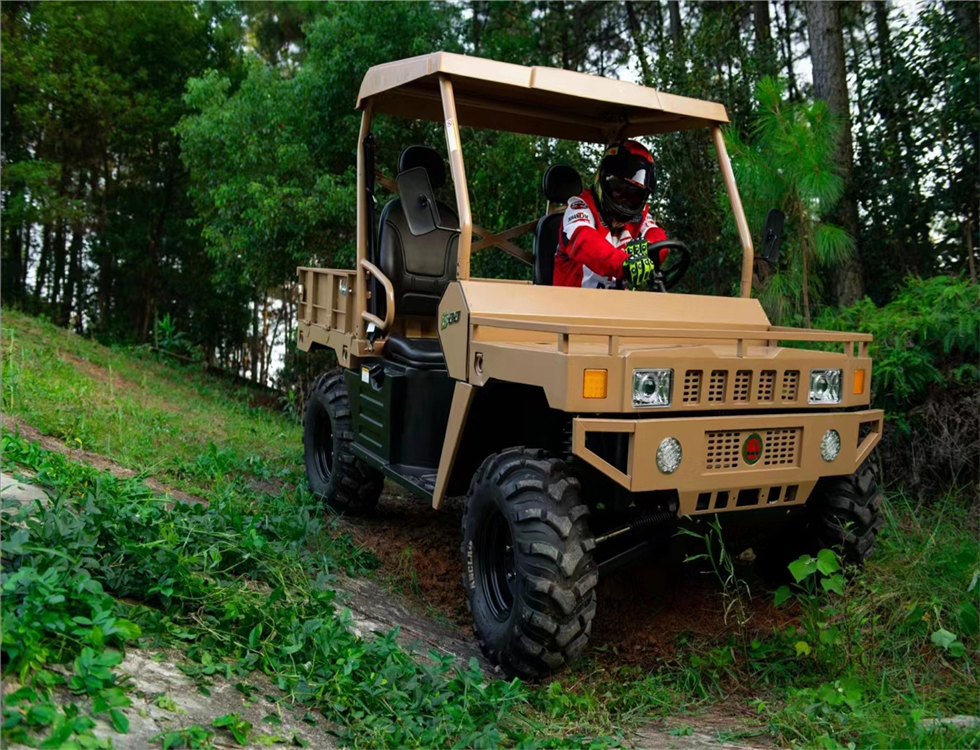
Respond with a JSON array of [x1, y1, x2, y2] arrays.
[[3, 434, 525, 746]]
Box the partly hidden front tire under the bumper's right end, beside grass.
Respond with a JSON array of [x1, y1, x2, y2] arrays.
[[807, 461, 884, 565]]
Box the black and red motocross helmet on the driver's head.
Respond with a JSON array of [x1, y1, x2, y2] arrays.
[[595, 141, 657, 224]]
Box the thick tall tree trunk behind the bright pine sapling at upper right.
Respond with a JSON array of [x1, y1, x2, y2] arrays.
[[806, 0, 864, 306]]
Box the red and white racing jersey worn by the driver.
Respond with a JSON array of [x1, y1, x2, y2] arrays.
[[554, 188, 667, 289]]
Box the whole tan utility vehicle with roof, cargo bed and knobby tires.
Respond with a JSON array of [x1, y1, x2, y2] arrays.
[[298, 52, 882, 678]]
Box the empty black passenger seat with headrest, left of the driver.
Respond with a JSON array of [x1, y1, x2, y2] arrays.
[[372, 146, 459, 369]]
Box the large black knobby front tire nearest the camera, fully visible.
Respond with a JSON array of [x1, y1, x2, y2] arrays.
[[462, 448, 598, 679]]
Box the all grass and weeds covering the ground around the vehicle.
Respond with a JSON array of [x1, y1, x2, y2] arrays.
[[0, 310, 980, 748]]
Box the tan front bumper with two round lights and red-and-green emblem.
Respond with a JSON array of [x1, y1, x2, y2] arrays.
[[572, 409, 884, 515]]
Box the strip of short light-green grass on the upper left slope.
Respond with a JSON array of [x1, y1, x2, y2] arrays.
[[0, 308, 302, 502]]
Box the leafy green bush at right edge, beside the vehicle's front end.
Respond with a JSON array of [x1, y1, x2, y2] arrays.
[[816, 276, 980, 495]]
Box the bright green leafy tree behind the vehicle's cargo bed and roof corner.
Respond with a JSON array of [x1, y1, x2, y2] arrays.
[[177, 3, 456, 293]]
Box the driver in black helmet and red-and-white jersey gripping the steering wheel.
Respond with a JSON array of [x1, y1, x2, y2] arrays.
[[554, 141, 669, 289]]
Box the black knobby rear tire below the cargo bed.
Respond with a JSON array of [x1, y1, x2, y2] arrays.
[[303, 370, 384, 513]]
